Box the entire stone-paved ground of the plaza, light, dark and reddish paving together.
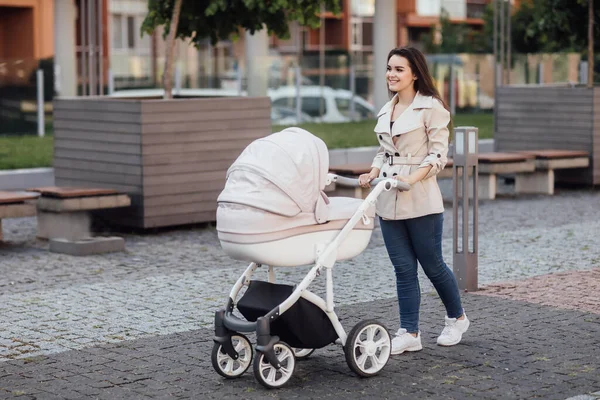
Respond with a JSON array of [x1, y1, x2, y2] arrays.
[[0, 191, 600, 399]]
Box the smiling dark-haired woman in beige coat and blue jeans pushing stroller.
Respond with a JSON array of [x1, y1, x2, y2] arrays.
[[359, 47, 469, 354]]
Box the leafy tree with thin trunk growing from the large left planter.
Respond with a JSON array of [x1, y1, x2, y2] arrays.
[[142, 0, 341, 98]]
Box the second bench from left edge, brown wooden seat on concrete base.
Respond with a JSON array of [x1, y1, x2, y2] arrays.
[[30, 186, 131, 255]]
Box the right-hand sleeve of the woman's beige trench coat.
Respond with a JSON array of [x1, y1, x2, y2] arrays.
[[419, 99, 450, 179]]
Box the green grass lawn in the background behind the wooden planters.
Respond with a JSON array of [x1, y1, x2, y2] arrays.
[[0, 113, 494, 170]]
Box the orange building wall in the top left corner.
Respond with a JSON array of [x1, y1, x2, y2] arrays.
[[0, 0, 54, 58]]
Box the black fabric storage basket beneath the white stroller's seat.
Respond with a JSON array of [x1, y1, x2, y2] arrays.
[[237, 280, 338, 349]]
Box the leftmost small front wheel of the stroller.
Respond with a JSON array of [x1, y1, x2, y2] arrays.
[[211, 333, 252, 379]]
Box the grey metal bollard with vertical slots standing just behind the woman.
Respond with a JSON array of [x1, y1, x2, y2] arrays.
[[452, 127, 479, 291]]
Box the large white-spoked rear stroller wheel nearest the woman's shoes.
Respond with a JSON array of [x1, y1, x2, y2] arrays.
[[344, 320, 392, 377]]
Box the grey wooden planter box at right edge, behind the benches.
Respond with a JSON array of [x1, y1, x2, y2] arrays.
[[494, 86, 600, 185]]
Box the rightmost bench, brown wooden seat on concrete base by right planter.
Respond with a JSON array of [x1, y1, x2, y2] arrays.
[[515, 150, 590, 195]]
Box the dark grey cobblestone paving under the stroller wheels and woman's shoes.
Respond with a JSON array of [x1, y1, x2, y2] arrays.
[[0, 294, 600, 399]]
